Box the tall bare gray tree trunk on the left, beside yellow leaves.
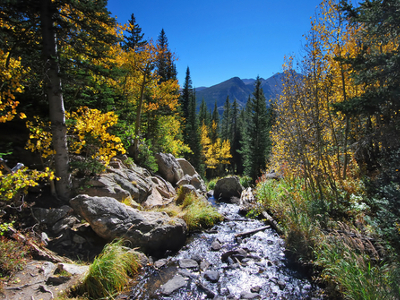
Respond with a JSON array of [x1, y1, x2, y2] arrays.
[[40, 0, 72, 201]]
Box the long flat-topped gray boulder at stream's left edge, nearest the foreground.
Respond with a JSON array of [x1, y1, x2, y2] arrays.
[[70, 195, 187, 254]]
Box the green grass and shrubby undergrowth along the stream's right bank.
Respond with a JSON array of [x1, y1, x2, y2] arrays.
[[255, 178, 400, 300]]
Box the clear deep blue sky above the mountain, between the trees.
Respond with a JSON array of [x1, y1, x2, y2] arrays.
[[107, 0, 321, 87]]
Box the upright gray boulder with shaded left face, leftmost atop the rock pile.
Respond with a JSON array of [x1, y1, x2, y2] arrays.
[[155, 153, 184, 186]]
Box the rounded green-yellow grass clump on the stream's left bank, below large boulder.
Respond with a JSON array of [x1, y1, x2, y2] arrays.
[[77, 240, 140, 299]]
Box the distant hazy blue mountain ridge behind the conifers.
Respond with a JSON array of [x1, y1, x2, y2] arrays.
[[196, 73, 290, 114]]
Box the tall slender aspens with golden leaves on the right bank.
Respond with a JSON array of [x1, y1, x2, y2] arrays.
[[271, 0, 362, 199]]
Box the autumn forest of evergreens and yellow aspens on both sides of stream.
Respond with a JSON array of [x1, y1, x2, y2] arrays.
[[0, 0, 400, 299]]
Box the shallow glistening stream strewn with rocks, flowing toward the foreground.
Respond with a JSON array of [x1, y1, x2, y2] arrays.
[[128, 198, 323, 300]]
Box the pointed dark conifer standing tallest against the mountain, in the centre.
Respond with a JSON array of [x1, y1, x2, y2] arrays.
[[241, 76, 269, 180]]
